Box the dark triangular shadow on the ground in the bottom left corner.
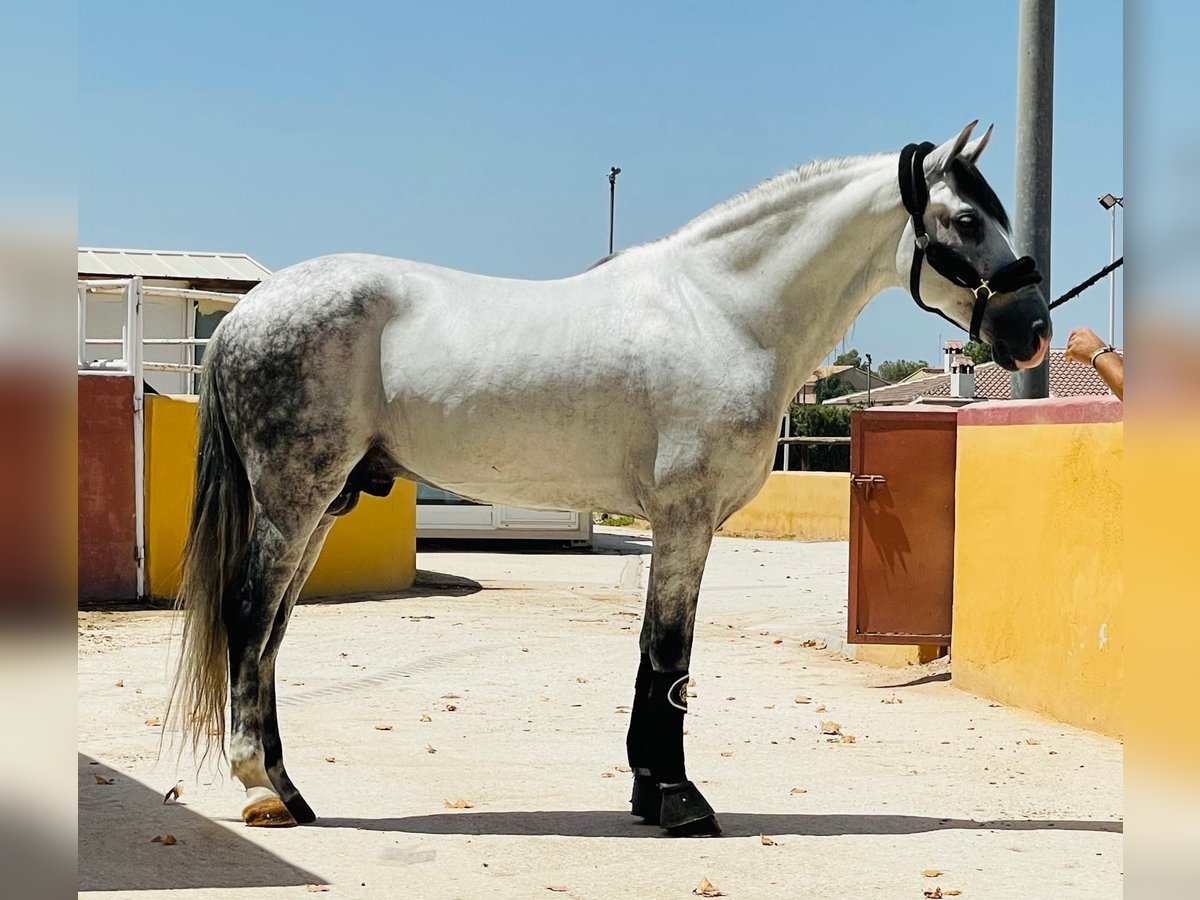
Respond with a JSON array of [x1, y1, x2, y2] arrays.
[[79, 754, 324, 892]]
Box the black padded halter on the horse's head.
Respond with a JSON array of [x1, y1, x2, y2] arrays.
[[900, 140, 1042, 341]]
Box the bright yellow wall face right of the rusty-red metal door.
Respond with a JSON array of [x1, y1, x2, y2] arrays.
[[952, 421, 1126, 736]]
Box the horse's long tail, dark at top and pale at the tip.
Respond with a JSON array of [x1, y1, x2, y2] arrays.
[[164, 350, 253, 766]]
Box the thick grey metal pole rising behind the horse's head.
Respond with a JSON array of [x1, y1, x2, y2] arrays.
[[1013, 0, 1054, 400]]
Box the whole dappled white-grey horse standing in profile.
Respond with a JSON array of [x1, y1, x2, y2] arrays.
[[168, 122, 1050, 834]]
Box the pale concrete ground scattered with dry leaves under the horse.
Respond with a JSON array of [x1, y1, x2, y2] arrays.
[[79, 529, 1122, 900]]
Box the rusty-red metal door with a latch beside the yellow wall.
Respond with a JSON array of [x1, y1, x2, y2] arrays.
[[847, 407, 958, 646]]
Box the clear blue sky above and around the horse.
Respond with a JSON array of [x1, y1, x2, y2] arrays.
[[78, 0, 1123, 361]]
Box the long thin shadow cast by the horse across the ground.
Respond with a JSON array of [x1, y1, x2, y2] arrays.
[[314, 810, 1123, 838]]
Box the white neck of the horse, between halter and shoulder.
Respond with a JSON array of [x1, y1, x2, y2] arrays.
[[673, 155, 906, 388]]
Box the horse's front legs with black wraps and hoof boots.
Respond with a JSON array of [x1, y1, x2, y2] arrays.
[[626, 511, 721, 835]]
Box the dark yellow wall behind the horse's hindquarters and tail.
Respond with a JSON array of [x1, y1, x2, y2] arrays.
[[145, 395, 416, 599]]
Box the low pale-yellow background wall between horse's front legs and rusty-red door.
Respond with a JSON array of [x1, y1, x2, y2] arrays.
[[720, 472, 850, 541]]
